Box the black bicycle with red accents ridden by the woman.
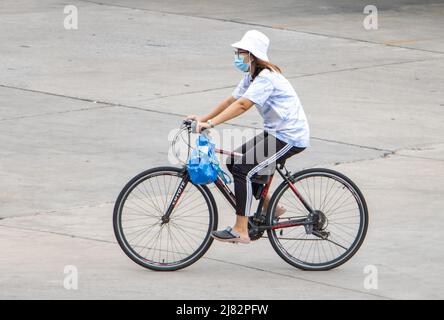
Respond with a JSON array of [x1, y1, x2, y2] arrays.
[[113, 120, 368, 271]]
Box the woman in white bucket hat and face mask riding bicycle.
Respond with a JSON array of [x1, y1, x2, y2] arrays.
[[187, 30, 310, 243]]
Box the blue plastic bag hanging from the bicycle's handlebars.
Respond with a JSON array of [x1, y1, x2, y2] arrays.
[[188, 135, 231, 184]]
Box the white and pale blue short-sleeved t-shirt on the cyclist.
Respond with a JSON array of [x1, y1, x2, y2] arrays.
[[232, 69, 310, 147]]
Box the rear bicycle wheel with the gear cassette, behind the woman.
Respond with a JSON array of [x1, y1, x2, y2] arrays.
[[267, 169, 368, 271]]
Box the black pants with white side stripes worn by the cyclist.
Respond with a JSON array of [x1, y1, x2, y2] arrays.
[[226, 131, 305, 216]]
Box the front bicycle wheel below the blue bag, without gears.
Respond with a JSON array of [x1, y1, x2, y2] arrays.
[[113, 167, 218, 271]]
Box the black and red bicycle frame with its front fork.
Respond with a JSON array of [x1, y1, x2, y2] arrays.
[[162, 124, 315, 231]]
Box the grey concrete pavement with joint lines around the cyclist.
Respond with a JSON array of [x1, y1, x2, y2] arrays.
[[0, 0, 444, 299]]
